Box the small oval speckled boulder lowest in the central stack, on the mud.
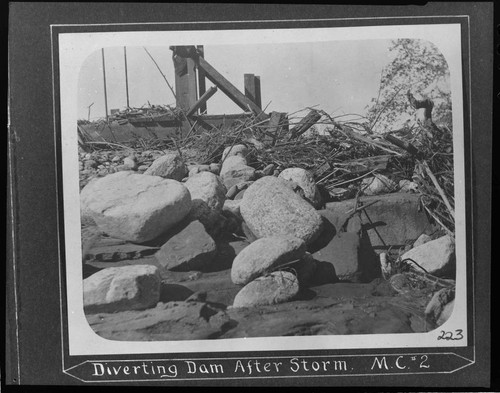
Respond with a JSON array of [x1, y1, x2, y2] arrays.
[[233, 271, 299, 308]]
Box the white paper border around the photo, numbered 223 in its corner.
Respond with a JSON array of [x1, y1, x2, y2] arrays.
[[53, 16, 473, 356]]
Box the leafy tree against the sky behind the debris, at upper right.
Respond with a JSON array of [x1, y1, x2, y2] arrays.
[[367, 39, 451, 133]]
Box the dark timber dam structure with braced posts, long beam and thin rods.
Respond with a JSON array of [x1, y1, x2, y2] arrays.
[[78, 45, 310, 147]]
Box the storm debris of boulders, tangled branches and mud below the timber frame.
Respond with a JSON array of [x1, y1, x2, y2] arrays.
[[80, 99, 455, 340]]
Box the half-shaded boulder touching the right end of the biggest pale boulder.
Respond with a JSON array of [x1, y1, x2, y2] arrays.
[[184, 172, 226, 230]]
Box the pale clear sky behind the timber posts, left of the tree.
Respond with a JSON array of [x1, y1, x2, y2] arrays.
[[77, 40, 392, 120]]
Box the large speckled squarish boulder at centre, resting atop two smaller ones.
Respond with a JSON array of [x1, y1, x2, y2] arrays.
[[240, 176, 323, 244]]
